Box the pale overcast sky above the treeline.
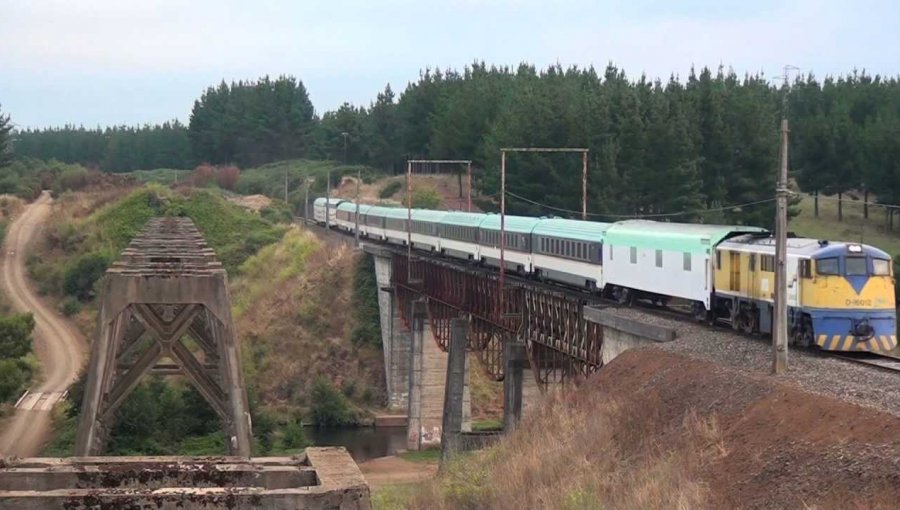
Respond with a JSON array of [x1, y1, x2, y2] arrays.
[[0, 0, 900, 127]]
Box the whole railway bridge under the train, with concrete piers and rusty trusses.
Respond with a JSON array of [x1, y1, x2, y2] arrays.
[[363, 243, 674, 449]]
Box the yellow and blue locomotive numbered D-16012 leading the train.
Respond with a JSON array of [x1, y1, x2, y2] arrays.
[[714, 235, 897, 353]]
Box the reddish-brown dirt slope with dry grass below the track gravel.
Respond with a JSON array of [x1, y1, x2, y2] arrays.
[[407, 349, 900, 510]]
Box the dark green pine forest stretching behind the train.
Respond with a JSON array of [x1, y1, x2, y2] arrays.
[[5, 62, 900, 225]]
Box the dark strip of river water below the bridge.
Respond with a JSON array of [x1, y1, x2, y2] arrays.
[[304, 427, 406, 463]]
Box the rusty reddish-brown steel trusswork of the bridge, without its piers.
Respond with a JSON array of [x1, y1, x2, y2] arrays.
[[391, 252, 603, 389]]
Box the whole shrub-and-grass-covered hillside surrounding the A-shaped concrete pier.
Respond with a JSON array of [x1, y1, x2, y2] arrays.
[[36, 185, 384, 455]]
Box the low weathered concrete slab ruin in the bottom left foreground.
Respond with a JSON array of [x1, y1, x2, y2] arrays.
[[0, 448, 371, 510]]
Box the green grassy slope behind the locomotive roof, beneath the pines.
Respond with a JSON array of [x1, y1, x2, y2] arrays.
[[788, 195, 900, 258]]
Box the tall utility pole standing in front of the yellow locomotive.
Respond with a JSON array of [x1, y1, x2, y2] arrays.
[[772, 66, 797, 375]]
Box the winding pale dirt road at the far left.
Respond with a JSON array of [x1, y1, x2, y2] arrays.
[[0, 191, 87, 457]]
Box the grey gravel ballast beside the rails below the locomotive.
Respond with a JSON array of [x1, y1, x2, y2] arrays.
[[616, 309, 900, 416]]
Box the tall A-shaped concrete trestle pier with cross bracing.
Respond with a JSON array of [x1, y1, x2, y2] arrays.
[[75, 218, 250, 457]]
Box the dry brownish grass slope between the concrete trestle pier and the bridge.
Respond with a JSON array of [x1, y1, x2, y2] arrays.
[[232, 228, 384, 422]]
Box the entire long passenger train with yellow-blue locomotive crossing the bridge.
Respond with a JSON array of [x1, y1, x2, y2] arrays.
[[313, 198, 897, 353]]
